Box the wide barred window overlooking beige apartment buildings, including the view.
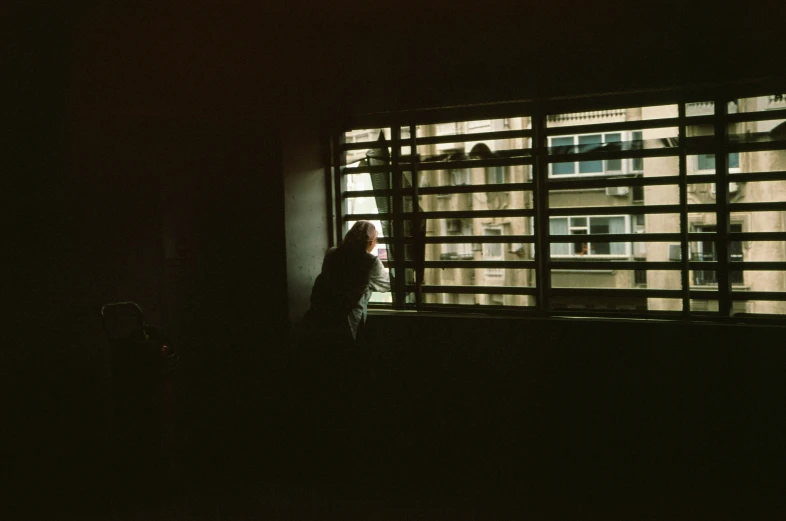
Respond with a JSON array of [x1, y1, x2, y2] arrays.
[[332, 86, 786, 319]]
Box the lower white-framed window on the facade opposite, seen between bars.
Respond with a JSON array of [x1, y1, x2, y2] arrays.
[[549, 215, 630, 257]]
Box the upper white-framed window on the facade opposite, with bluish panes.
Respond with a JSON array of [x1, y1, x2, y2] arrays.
[[549, 132, 623, 176]]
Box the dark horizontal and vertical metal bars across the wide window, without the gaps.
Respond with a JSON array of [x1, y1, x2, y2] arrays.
[[326, 78, 786, 319]]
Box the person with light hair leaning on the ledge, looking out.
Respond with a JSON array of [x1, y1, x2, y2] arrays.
[[304, 221, 390, 348]]
